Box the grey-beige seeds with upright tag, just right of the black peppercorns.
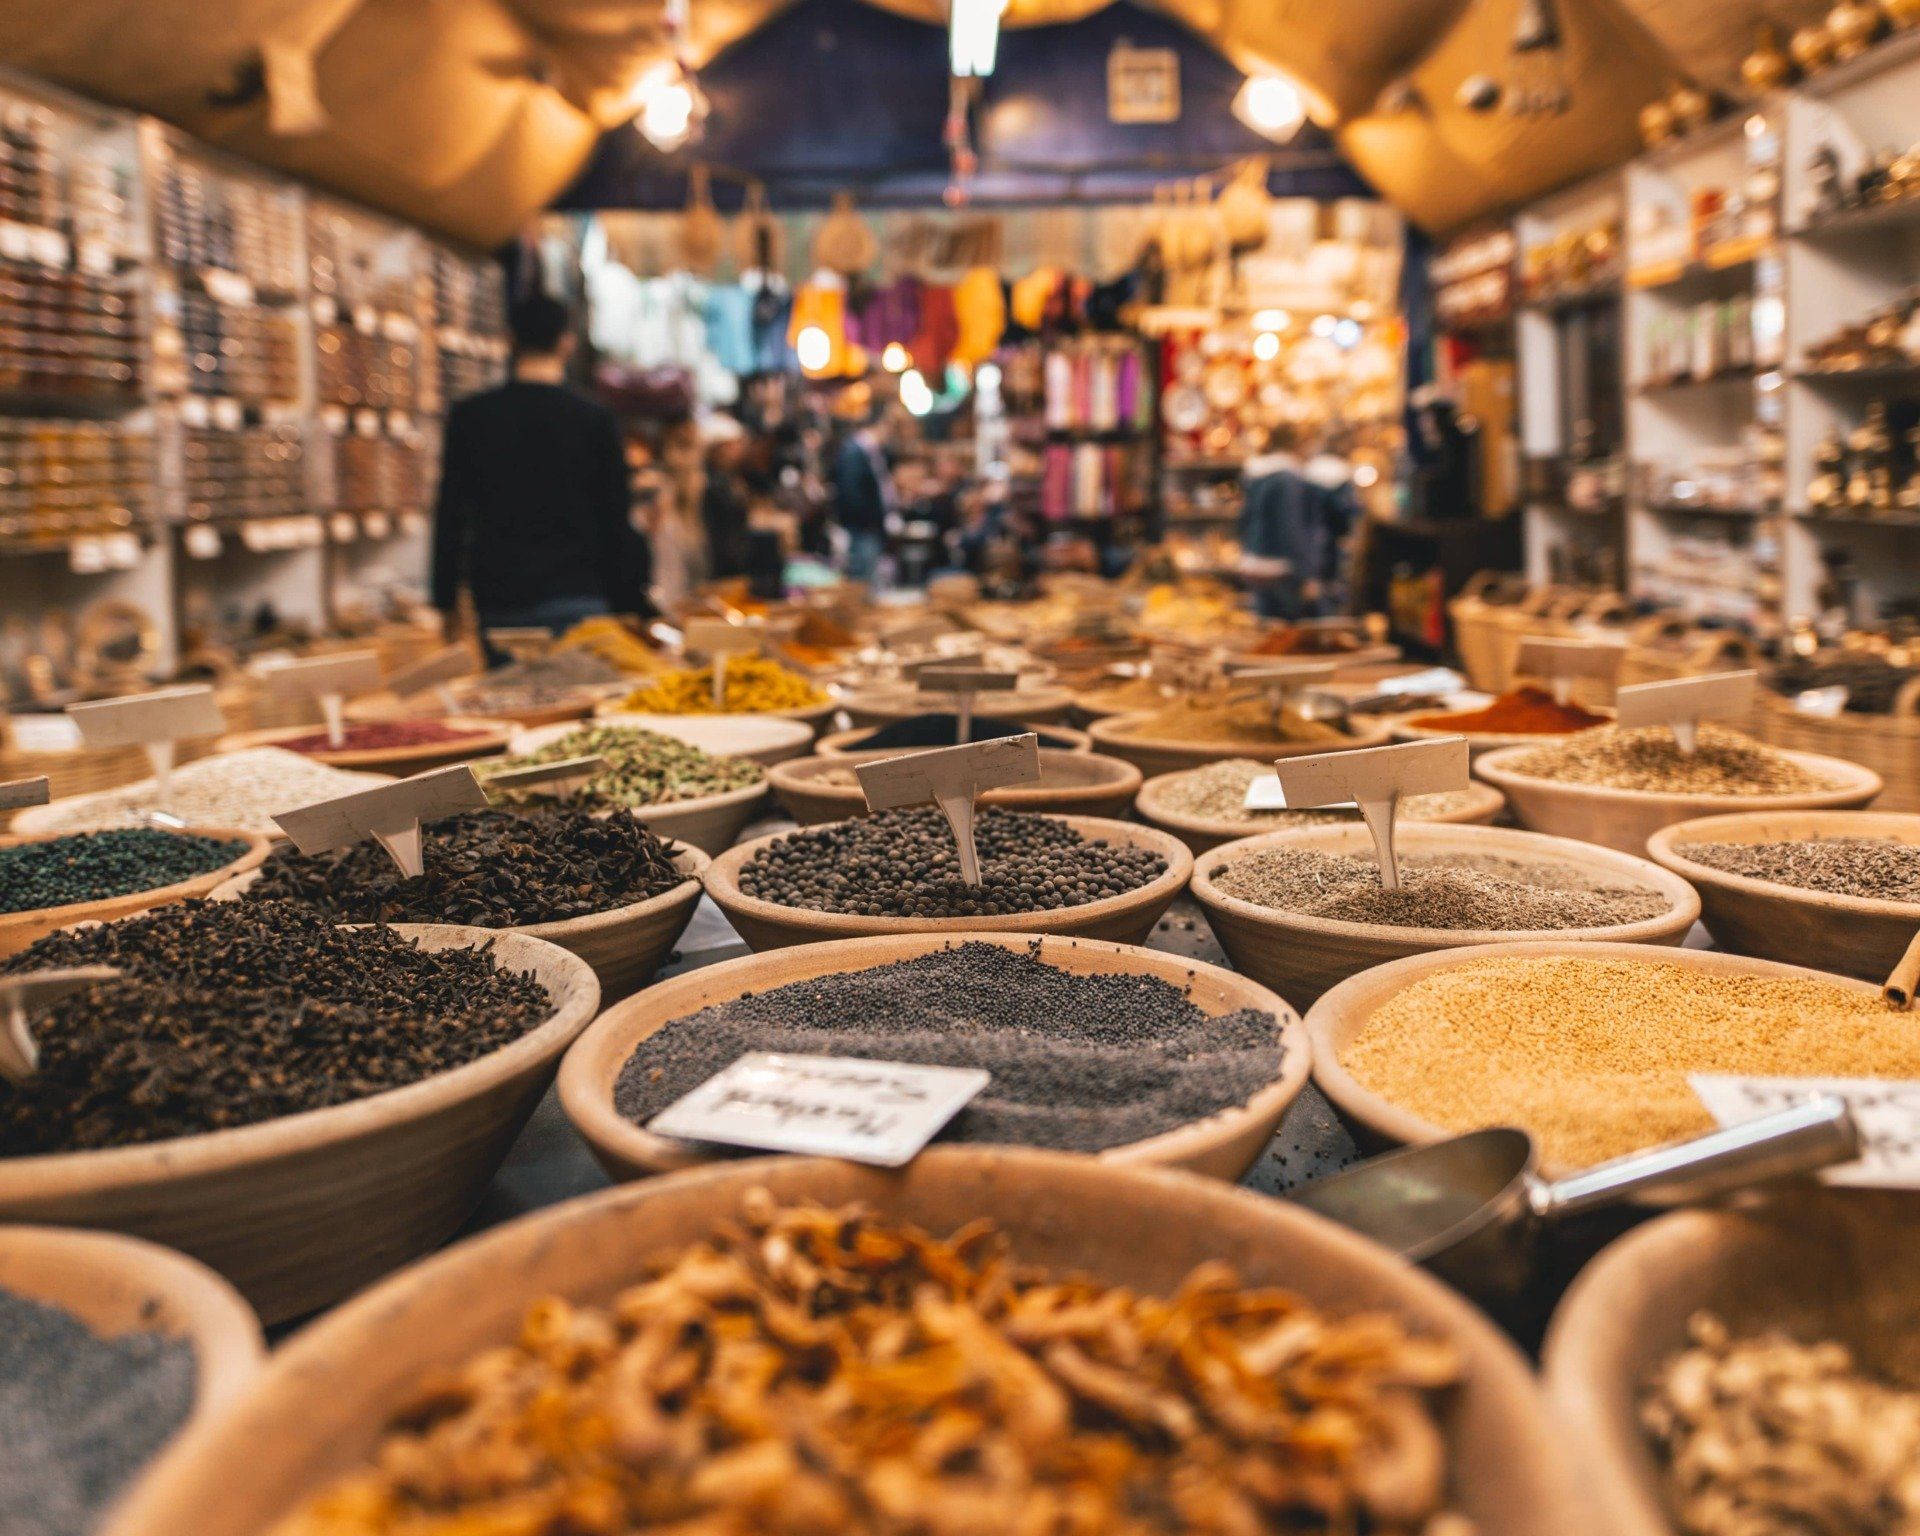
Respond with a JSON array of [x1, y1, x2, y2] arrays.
[[1213, 849, 1672, 931]]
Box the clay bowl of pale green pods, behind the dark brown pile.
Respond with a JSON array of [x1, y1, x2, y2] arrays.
[[480, 722, 768, 854]]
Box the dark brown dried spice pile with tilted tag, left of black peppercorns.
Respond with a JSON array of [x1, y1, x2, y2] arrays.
[[246, 804, 687, 927]]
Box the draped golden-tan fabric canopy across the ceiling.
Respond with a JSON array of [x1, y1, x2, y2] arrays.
[[0, 0, 1826, 244]]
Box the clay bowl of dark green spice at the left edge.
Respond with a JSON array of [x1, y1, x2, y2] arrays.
[[0, 828, 271, 960]]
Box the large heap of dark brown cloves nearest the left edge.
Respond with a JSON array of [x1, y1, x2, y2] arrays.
[[0, 900, 553, 1158]]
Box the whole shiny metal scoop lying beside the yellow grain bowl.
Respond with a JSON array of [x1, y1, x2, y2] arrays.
[[1292, 1094, 1860, 1298]]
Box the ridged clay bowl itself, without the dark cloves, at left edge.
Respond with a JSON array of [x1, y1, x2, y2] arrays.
[[0, 924, 599, 1323]]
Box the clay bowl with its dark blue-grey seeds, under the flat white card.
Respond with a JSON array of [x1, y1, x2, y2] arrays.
[[559, 933, 1308, 1179]]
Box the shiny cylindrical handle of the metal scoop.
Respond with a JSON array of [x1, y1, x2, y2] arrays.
[[1528, 1094, 1860, 1221]]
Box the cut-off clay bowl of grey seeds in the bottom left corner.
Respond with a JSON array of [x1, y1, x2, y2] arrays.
[[0, 1227, 267, 1536]]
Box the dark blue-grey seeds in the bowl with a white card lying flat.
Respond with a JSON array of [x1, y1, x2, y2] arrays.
[[614, 945, 1281, 1152]]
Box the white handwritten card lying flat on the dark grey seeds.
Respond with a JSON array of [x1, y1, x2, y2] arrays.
[[647, 1050, 989, 1167]]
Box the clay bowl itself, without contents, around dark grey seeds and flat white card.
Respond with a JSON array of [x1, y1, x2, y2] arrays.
[[559, 933, 1309, 1179]]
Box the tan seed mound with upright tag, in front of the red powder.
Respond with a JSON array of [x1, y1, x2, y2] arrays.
[[1507, 722, 1839, 795]]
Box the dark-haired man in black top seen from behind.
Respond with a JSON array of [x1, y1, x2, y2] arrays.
[[434, 294, 653, 634]]
